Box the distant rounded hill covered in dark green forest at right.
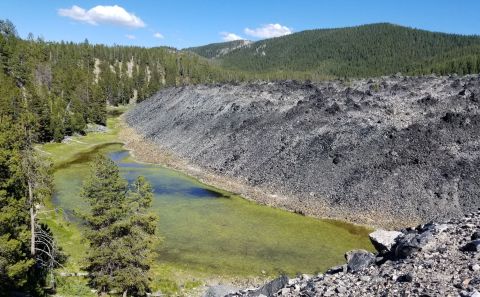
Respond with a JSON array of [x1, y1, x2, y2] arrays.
[[205, 23, 480, 79]]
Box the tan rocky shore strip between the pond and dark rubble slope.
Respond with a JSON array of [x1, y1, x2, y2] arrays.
[[118, 117, 384, 228]]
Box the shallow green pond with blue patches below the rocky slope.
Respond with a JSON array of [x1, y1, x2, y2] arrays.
[[53, 144, 371, 276]]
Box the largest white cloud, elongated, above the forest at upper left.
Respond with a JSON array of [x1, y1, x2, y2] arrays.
[[58, 5, 146, 28]]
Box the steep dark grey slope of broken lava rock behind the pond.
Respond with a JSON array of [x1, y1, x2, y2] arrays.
[[125, 76, 480, 226]]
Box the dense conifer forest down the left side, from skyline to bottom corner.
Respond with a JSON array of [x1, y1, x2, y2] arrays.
[[0, 20, 246, 296]]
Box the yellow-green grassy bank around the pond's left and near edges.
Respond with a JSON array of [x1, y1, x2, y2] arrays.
[[37, 110, 203, 297]]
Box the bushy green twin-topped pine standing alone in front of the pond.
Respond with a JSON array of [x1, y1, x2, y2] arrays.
[[82, 156, 157, 296]]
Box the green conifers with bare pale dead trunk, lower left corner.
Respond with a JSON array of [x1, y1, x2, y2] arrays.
[[0, 115, 57, 296]]
